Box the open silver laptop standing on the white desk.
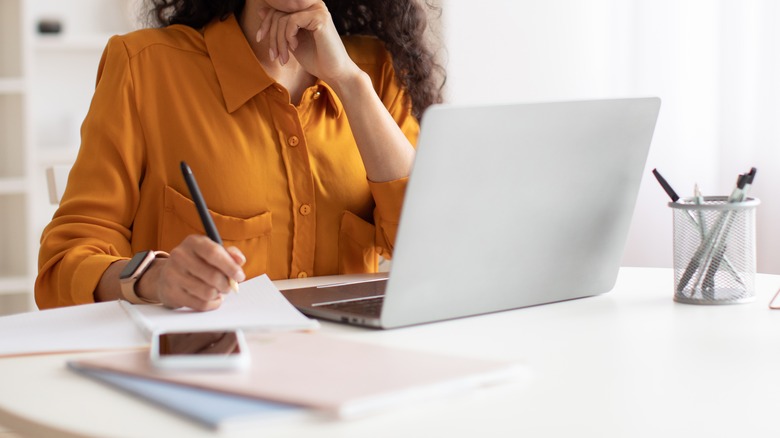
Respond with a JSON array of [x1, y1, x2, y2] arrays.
[[283, 97, 661, 328]]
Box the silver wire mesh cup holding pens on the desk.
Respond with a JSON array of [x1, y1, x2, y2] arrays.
[[669, 196, 761, 304]]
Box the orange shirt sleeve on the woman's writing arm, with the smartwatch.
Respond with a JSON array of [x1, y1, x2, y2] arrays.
[[35, 37, 144, 309]]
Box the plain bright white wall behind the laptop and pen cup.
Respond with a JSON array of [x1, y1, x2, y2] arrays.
[[443, 0, 780, 273]]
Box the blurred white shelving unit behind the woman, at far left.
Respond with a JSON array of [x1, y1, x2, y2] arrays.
[[0, 0, 133, 311]]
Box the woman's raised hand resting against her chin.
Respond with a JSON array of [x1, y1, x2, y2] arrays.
[[256, 1, 360, 84]]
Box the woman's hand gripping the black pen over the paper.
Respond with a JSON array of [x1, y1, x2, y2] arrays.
[[142, 234, 246, 311]]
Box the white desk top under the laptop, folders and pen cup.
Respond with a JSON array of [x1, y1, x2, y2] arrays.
[[0, 268, 780, 437]]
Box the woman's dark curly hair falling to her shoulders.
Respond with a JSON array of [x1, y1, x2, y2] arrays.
[[149, 0, 446, 120]]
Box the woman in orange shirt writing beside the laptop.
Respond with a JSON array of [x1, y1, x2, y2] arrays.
[[35, 0, 440, 310]]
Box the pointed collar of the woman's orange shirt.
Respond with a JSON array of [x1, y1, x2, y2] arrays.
[[203, 15, 344, 117]]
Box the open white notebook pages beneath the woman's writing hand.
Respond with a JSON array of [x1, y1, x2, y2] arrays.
[[0, 275, 319, 357]]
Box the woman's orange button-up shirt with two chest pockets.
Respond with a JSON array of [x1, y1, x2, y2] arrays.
[[35, 17, 419, 308]]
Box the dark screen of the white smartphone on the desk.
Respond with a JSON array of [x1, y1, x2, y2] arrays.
[[158, 331, 241, 357]]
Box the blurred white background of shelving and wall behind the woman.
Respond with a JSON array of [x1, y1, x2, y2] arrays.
[[0, 0, 780, 314]]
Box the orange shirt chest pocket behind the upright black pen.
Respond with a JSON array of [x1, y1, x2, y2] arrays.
[[158, 187, 272, 278]]
